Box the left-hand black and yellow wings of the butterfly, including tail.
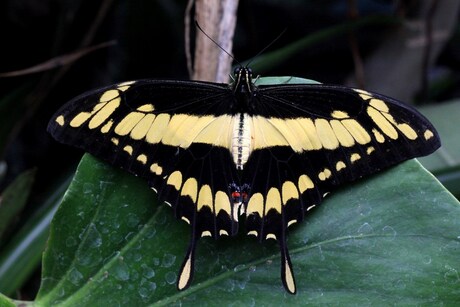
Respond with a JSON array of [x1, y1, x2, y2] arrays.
[[48, 80, 244, 288]]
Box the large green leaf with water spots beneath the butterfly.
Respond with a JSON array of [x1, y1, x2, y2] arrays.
[[12, 155, 460, 306]]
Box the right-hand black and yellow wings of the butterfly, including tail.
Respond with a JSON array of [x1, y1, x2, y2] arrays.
[[242, 85, 440, 293]]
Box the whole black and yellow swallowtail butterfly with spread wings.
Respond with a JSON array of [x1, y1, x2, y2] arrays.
[[48, 67, 440, 293]]
